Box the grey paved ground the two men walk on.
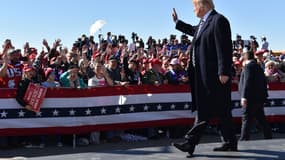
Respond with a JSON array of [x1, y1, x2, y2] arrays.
[[0, 134, 285, 160]]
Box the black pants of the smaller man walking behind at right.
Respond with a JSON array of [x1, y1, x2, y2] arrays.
[[240, 103, 272, 140]]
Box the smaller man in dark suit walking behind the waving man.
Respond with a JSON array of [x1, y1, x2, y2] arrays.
[[239, 51, 272, 140]]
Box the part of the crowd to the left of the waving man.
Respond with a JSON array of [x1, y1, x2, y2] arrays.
[[0, 33, 190, 91]]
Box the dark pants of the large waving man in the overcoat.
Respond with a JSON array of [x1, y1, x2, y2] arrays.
[[185, 108, 237, 145]]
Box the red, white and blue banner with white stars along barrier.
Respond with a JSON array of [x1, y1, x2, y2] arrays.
[[0, 84, 285, 136]]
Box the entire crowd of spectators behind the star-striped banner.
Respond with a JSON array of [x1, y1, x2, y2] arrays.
[[0, 32, 285, 149]]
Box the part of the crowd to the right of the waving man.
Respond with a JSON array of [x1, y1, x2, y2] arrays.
[[233, 35, 285, 83]]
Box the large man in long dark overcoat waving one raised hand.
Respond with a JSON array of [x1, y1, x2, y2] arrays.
[[172, 0, 237, 156]]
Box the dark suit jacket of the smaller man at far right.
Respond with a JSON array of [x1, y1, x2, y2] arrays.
[[239, 60, 268, 103]]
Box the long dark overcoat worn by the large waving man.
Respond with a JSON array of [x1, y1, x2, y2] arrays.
[[176, 10, 232, 120]]
